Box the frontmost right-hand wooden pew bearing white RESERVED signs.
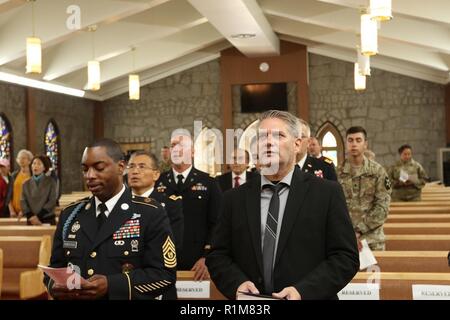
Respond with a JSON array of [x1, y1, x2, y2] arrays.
[[352, 272, 450, 300]]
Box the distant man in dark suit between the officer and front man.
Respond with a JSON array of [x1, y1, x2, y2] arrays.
[[216, 148, 252, 192]]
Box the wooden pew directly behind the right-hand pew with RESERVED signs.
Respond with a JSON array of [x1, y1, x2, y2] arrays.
[[373, 251, 450, 273]]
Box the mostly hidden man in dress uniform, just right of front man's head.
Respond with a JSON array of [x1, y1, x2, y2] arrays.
[[296, 119, 337, 181]]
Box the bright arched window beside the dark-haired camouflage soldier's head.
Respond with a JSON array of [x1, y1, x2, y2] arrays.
[[317, 122, 345, 166]]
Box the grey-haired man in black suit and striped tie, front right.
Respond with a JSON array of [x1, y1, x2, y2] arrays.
[[207, 110, 359, 300]]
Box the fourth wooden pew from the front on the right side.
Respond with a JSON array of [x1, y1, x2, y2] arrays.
[[383, 222, 450, 235]]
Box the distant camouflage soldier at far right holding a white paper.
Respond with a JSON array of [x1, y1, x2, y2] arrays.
[[389, 144, 428, 201]]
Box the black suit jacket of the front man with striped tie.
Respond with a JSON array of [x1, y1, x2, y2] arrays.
[[206, 167, 359, 299]]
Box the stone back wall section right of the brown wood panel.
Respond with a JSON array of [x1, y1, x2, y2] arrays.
[[309, 54, 446, 177]]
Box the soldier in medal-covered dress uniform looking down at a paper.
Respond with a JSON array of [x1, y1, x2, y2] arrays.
[[44, 139, 177, 299]]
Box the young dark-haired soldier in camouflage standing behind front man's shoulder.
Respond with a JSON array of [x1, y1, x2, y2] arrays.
[[338, 127, 391, 250]]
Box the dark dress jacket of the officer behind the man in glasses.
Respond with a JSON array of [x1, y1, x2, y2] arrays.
[[155, 168, 222, 270]]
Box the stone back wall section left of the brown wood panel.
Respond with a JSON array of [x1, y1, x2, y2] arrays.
[[103, 60, 222, 156]]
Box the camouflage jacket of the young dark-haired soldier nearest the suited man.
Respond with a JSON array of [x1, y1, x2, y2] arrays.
[[338, 157, 391, 244]]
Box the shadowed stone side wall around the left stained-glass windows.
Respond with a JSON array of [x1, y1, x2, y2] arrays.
[[0, 83, 94, 193]]
